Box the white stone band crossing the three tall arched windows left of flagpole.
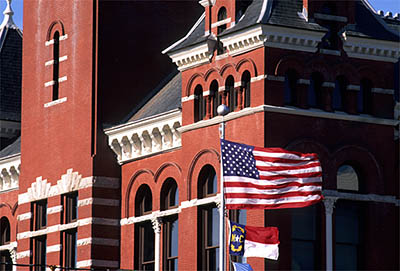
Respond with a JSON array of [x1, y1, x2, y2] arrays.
[[120, 194, 221, 226]]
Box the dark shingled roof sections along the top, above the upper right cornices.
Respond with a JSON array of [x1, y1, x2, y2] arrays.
[[165, 0, 400, 53]]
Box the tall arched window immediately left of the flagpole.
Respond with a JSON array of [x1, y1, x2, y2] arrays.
[[197, 165, 219, 270]]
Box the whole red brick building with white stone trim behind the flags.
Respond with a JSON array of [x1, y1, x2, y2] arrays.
[[0, 0, 400, 270]]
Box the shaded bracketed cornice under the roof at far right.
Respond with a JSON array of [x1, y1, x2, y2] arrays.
[[342, 32, 400, 63]]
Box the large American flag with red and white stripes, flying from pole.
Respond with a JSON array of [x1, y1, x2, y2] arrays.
[[221, 139, 322, 209]]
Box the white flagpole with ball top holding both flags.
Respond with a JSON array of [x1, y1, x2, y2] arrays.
[[217, 104, 229, 271]]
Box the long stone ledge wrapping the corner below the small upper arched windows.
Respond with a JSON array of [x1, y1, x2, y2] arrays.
[[178, 105, 399, 133]]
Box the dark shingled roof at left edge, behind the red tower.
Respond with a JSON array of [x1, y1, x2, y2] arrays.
[[0, 26, 22, 121]]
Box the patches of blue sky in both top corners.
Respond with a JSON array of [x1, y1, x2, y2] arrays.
[[0, 0, 400, 29]]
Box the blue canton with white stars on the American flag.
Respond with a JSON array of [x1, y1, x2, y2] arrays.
[[221, 139, 260, 179]]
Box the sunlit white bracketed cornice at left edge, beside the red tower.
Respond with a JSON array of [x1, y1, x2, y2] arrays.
[[0, 154, 21, 193]]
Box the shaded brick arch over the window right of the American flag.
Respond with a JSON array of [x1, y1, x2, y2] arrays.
[[331, 145, 385, 194]]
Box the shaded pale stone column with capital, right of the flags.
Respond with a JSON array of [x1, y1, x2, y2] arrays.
[[323, 197, 337, 270]]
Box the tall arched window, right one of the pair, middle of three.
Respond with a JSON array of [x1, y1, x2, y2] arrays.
[[161, 178, 179, 270]]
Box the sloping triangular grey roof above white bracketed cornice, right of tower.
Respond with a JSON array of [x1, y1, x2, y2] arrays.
[[127, 73, 182, 122]]
